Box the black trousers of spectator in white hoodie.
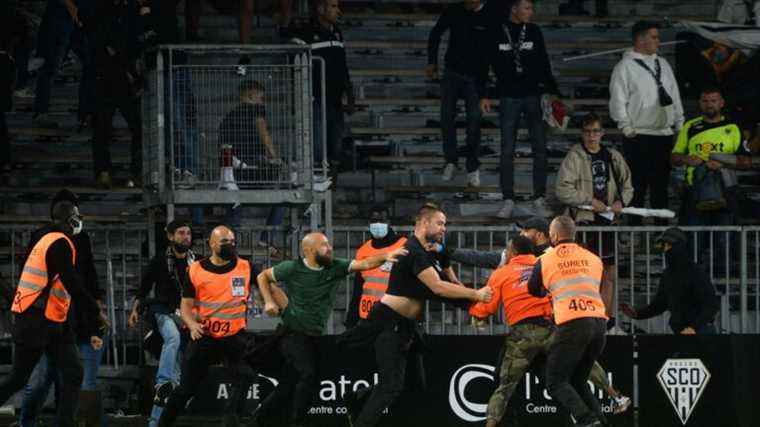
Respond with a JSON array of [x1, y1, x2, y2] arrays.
[[623, 135, 673, 225]]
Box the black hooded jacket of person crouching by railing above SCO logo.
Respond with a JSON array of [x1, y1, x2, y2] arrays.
[[636, 244, 720, 334]]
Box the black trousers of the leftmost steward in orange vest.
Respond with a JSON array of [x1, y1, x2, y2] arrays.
[[0, 325, 84, 427]]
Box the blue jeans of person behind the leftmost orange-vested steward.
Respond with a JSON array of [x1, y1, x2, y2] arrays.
[[19, 340, 105, 427]]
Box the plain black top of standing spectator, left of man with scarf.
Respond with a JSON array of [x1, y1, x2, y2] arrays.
[[427, 3, 496, 85]]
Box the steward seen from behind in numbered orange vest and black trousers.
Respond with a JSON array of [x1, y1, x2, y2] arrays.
[[528, 216, 607, 427]]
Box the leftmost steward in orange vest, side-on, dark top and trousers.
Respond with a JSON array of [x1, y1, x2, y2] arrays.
[[0, 201, 106, 427]]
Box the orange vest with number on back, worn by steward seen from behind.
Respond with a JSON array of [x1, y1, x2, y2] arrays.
[[540, 243, 607, 325]]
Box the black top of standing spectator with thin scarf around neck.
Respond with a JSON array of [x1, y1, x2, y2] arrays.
[[481, 17, 559, 98]]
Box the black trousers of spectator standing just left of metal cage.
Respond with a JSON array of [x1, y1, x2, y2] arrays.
[[92, 96, 142, 178]]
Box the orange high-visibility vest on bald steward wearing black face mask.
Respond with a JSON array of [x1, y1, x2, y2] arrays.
[[189, 258, 251, 338]]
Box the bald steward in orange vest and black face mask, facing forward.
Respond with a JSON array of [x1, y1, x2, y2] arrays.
[[158, 226, 286, 427]]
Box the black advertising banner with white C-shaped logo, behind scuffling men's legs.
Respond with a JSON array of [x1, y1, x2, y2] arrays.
[[181, 336, 633, 427]]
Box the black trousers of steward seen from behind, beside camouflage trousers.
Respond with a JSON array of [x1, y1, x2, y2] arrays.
[[546, 317, 607, 424]]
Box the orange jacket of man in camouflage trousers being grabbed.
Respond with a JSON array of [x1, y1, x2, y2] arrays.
[[470, 254, 552, 326]]
